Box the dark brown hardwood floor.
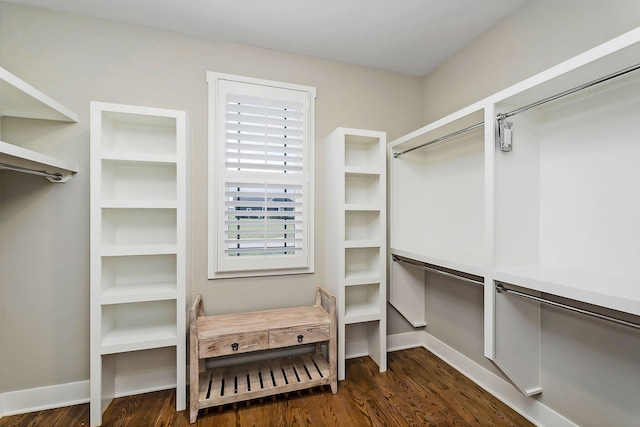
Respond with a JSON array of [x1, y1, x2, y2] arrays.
[[0, 348, 533, 427]]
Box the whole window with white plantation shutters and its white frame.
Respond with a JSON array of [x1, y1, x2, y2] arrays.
[[207, 72, 315, 279]]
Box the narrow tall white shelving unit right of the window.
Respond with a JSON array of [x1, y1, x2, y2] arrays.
[[326, 128, 387, 380]]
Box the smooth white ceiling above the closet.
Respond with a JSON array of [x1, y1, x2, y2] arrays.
[[8, 0, 530, 76]]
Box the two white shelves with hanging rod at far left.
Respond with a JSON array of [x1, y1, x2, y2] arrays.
[[0, 67, 78, 182]]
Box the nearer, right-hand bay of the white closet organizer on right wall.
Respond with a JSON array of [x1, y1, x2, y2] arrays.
[[489, 26, 640, 394]]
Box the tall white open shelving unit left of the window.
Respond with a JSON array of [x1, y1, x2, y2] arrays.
[[91, 102, 187, 426]]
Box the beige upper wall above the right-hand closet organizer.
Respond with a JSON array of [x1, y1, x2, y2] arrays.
[[423, 0, 640, 123]]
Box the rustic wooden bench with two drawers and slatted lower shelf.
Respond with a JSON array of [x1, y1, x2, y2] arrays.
[[189, 286, 338, 423]]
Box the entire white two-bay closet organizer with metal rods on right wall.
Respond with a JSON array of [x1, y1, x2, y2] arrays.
[[389, 28, 640, 395]]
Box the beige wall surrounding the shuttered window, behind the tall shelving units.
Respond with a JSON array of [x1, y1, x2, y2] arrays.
[[0, 2, 422, 392]]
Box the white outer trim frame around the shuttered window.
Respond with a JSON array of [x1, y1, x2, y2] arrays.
[[207, 71, 316, 279]]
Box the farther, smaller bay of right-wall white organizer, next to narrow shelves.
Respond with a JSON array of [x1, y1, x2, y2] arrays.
[[389, 106, 485, 327]]
